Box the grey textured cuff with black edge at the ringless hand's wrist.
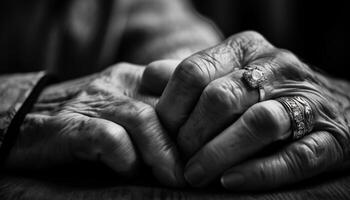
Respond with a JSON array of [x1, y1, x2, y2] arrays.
[[0, 72, 48, 161]]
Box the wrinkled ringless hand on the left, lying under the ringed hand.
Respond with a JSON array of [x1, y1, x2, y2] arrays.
[[6, 64, 184, 186]]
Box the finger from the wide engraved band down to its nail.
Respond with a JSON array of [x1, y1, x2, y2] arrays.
[[185, 100, 291, 187]]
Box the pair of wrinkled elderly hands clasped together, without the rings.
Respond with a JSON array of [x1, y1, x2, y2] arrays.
[[6, 32, 350, 190]]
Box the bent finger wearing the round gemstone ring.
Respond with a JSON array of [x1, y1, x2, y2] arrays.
[[177, 51, 312, 156]]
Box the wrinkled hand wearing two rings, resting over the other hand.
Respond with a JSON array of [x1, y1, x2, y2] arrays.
[[149, 32, 350, 190]]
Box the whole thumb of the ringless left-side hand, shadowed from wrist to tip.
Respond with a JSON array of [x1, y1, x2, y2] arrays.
[[5, 114, 138, 176]]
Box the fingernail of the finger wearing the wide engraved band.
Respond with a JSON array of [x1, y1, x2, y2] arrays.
[[185, 163, 204, 186]]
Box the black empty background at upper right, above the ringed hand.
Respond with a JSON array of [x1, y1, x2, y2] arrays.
[[193, 0, 350, 80]]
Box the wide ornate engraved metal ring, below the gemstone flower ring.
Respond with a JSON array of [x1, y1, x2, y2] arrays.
[[276, 96, 314, 140]]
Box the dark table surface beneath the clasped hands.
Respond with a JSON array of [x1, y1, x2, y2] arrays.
[[0, 164, 350, 200]]
